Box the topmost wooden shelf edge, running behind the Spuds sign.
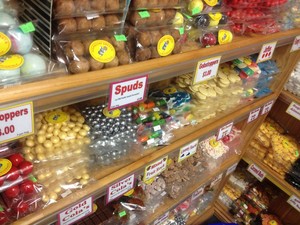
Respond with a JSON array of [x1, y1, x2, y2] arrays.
[[0, 29, 300, 112]]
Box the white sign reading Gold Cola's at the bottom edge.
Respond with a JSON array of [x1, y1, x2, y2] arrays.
[[58, 197, 93, 225]]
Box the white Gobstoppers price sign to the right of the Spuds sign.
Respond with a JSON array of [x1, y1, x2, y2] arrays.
[[194, 56, 221, 84]]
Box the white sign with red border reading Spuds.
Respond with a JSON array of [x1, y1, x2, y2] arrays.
[[108, 75, 148, 110]]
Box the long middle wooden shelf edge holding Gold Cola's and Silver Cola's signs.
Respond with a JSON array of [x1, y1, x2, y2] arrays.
[[11, 93, 276, 224]]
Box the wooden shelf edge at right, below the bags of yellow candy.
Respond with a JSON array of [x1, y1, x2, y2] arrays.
[[243, 152, 300, 198]]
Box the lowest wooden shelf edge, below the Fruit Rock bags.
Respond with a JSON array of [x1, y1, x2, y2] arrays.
[[147, 156, 240, 224]]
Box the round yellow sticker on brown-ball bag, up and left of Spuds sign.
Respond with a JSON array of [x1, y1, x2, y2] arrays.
[[89, 40, 116, 63]]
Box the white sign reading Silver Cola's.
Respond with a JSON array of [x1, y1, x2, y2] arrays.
[[106, 174, 135, 203]]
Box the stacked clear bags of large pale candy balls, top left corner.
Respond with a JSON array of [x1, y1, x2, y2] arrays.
[[0, 0, 64, 87]]
